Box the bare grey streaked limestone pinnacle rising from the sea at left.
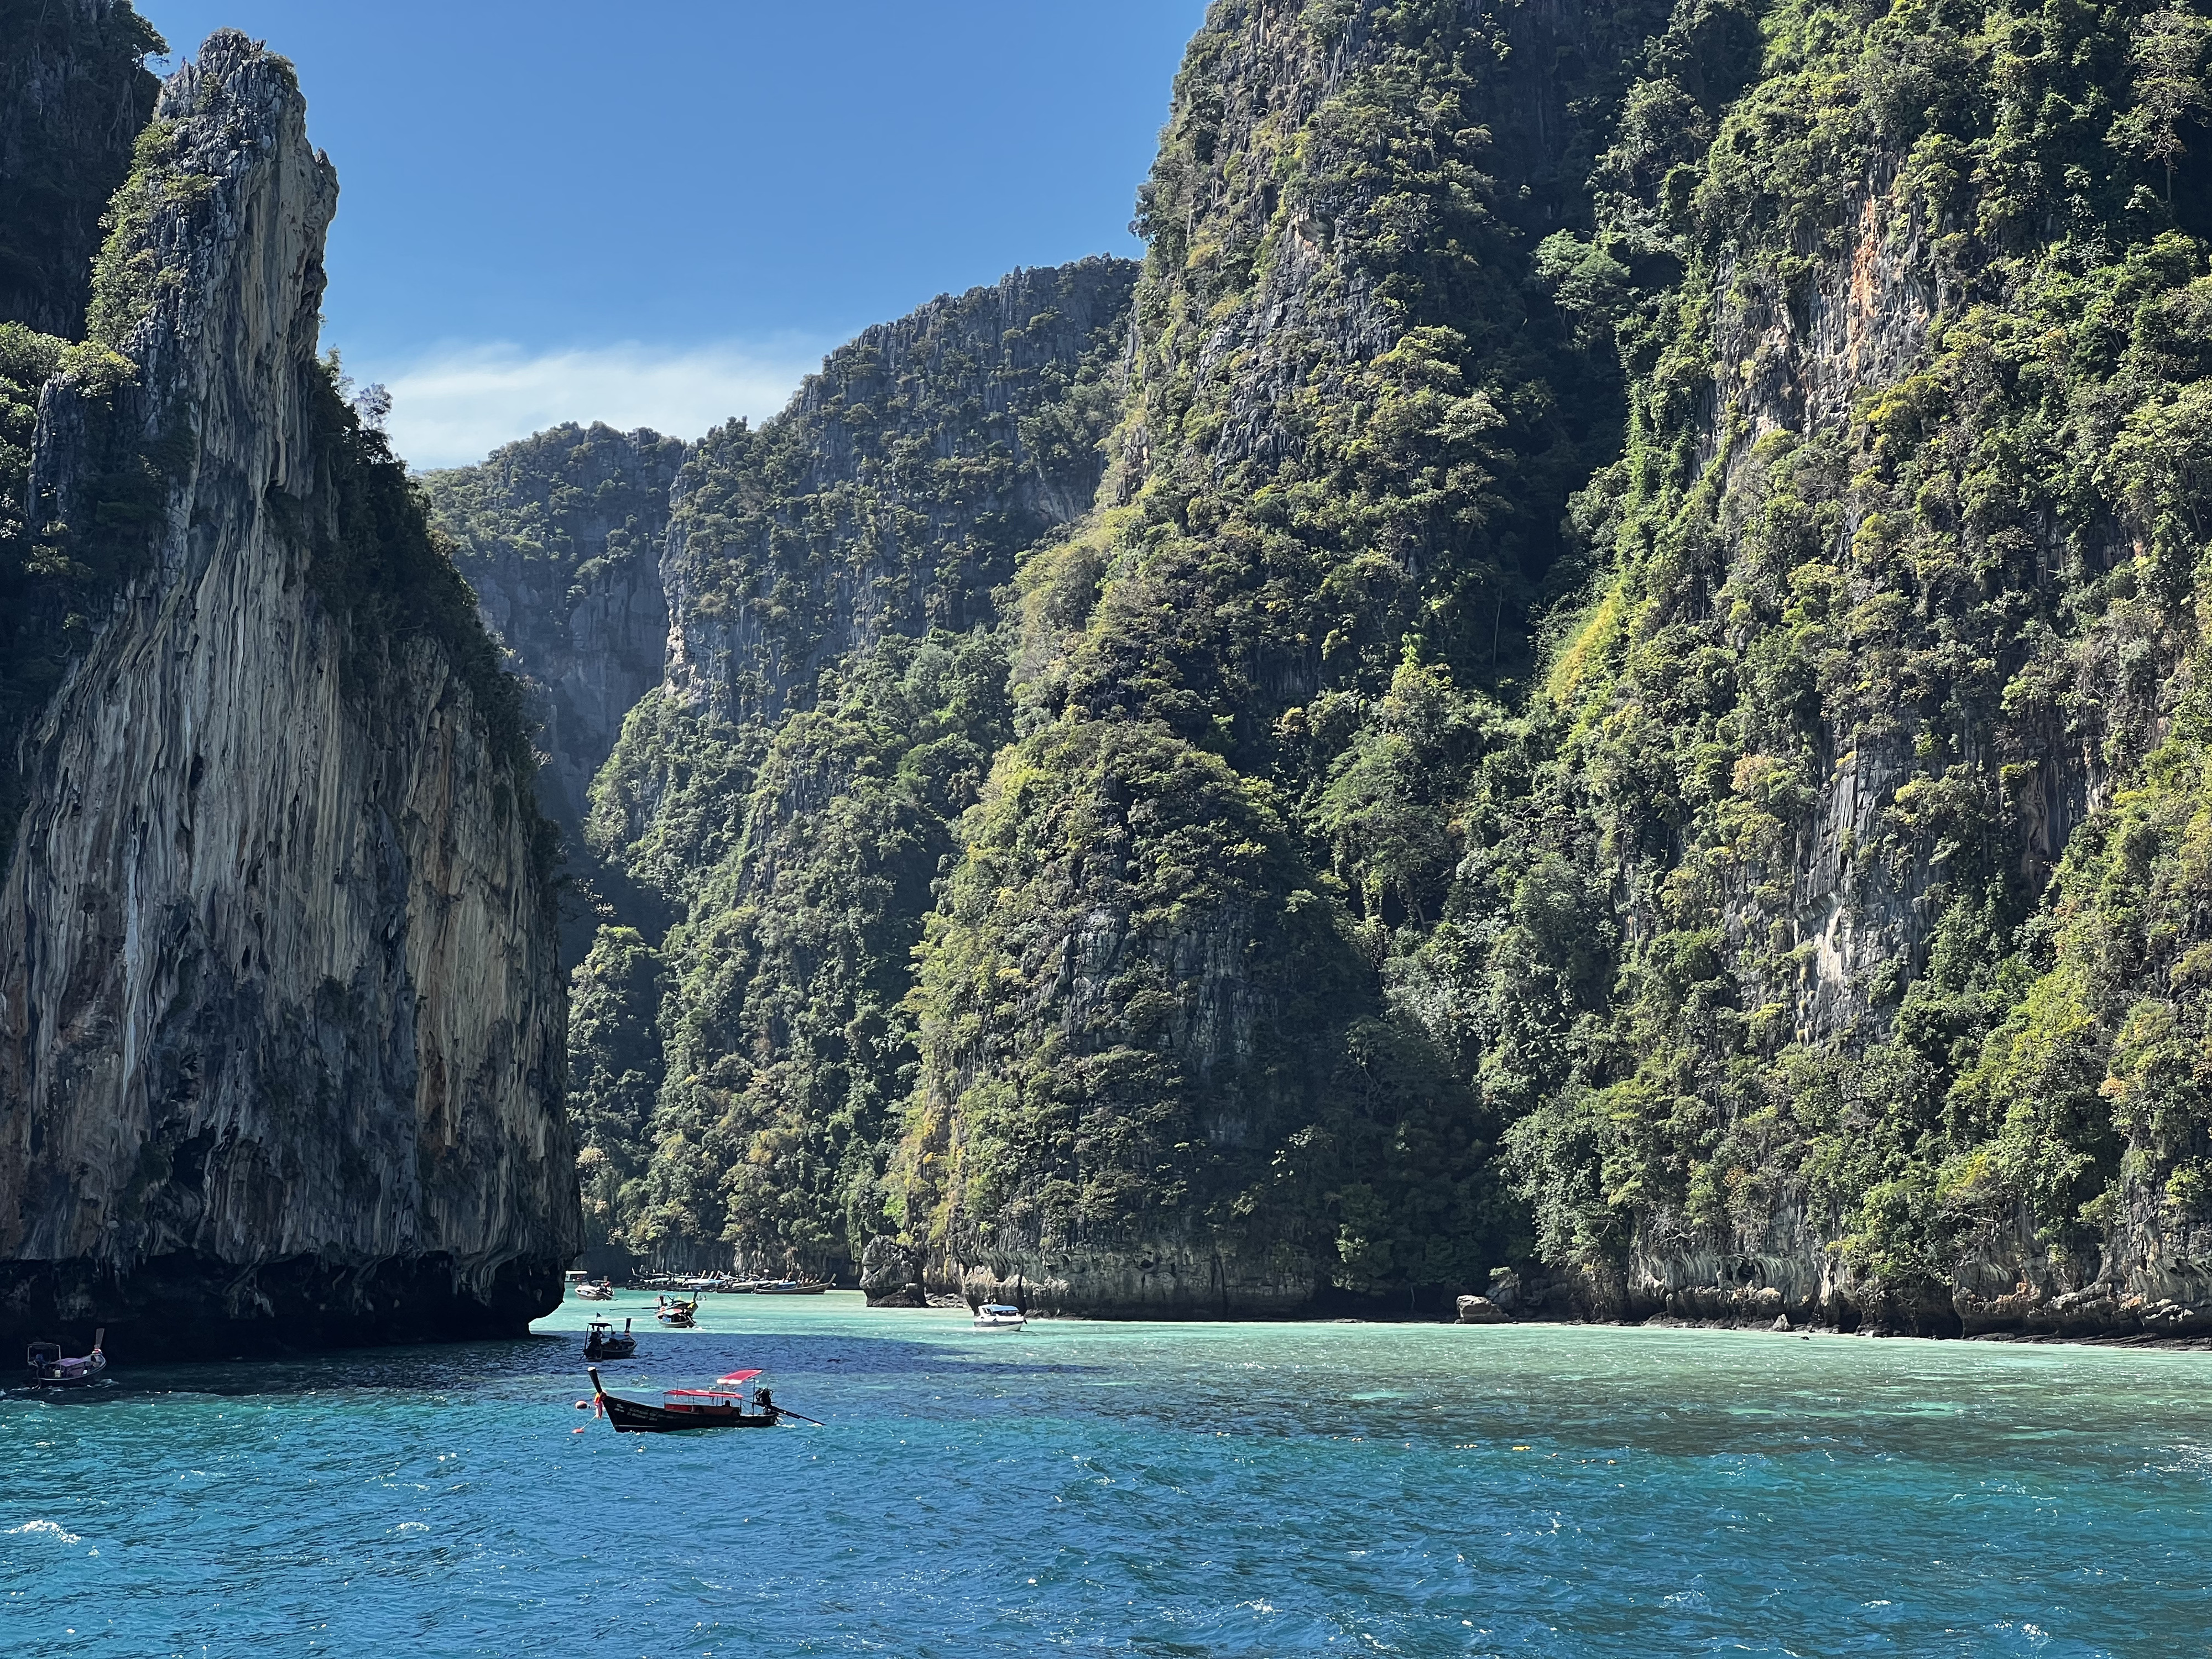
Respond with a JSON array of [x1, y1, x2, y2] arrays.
[[0, 31, 580, 1356]]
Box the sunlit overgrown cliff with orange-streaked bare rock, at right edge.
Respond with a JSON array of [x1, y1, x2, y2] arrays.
[[1460, 0, 2212, 1327]]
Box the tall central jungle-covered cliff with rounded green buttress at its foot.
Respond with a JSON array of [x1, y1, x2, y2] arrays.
[[898, 0, 1659, 1314]]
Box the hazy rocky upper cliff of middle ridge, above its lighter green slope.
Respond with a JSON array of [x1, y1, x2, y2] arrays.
[[670, 259, 1135, 734]]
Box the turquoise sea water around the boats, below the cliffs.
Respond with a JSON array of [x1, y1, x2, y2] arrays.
[[0, 1294, 2212, 1659]]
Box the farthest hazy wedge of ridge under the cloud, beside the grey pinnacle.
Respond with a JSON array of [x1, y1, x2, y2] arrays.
[[422, 422, 684, 845]]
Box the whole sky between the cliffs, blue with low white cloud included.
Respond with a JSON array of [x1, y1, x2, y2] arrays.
[[137, 0, 1206, 467]]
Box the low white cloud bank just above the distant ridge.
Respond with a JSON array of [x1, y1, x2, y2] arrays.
[[358, 338, 825, 467]]
